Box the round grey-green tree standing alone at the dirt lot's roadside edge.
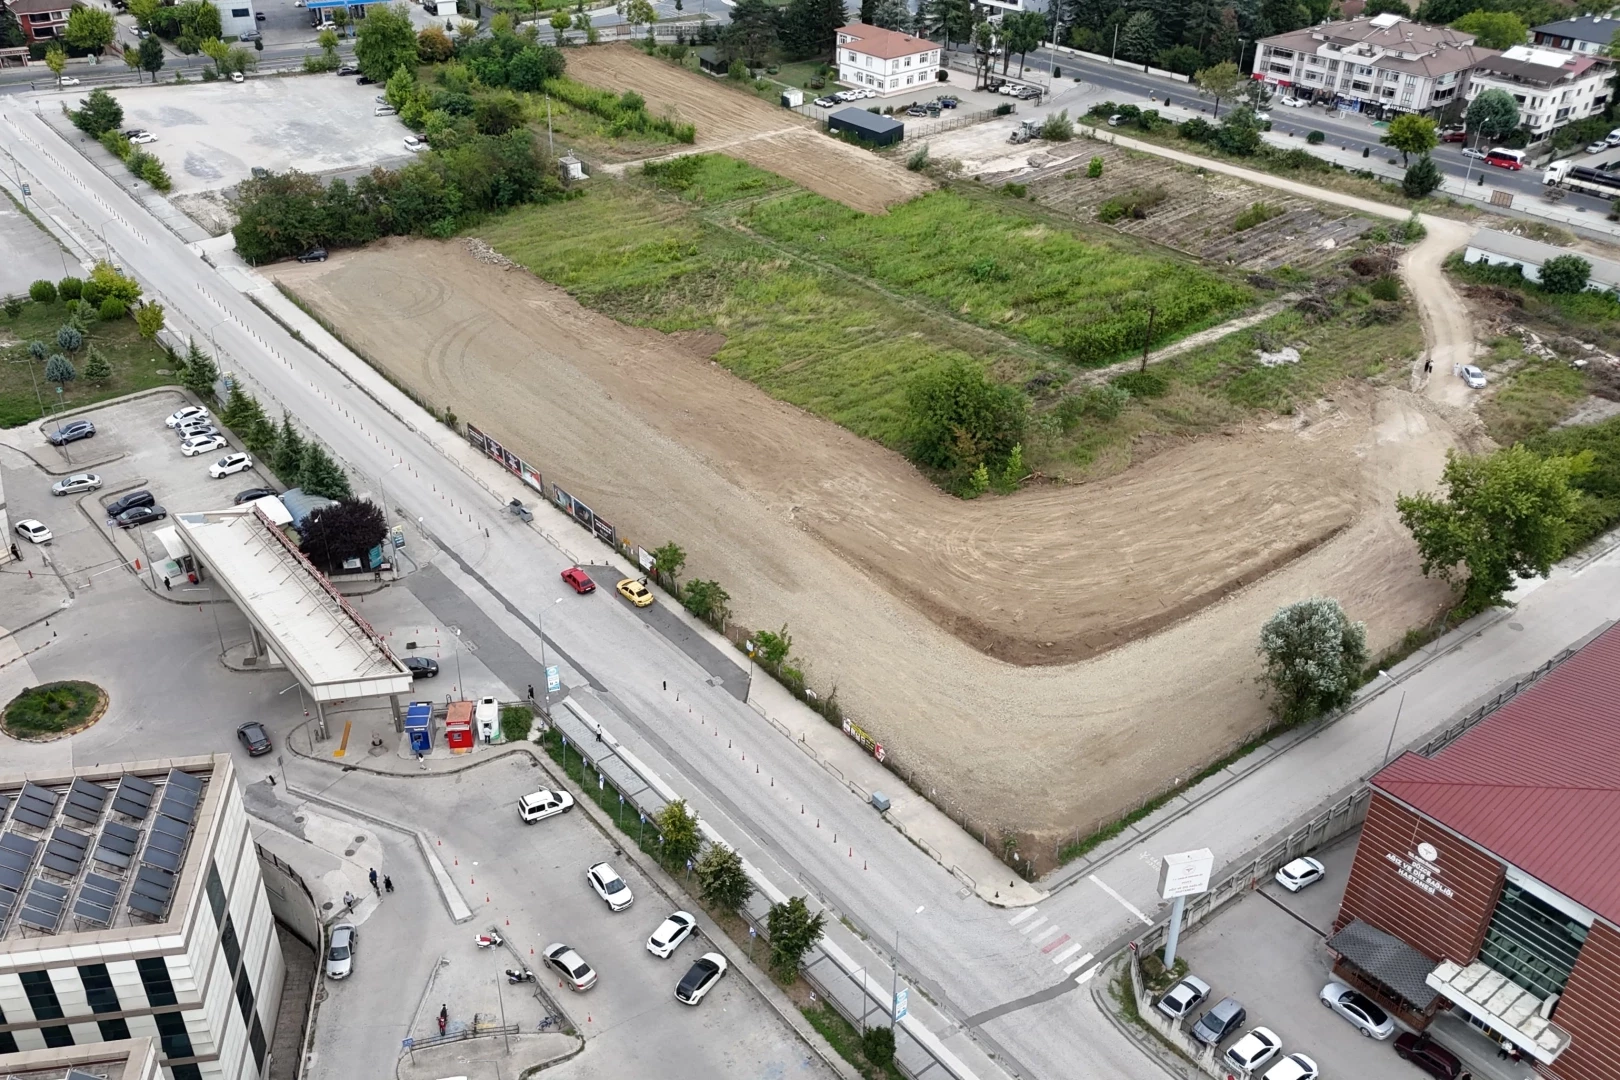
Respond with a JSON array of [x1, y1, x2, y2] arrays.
[[1259, 596, 1367, 724]]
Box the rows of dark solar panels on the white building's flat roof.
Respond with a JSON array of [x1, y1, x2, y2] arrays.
[[0, 769, 204, 936]]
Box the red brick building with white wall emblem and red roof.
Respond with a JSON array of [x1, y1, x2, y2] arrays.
[[1328, 627, 1620, 1080]]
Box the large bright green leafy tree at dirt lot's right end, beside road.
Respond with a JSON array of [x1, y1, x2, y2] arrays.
[[1395, 445, 1591, 617]]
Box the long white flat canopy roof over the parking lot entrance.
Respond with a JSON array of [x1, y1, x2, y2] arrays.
[[173, 505, 411, 701]]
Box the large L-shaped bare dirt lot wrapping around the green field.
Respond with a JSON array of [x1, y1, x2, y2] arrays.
[[279, 241, 1453, 832]]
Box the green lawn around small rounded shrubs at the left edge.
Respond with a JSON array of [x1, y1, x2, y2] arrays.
[[0, 303, 175, 427]]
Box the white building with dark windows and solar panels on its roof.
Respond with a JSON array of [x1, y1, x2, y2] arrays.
[[0, 755, 285, 1080]]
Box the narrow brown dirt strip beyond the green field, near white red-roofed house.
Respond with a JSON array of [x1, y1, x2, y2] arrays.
[[569, 45, 928, 214]]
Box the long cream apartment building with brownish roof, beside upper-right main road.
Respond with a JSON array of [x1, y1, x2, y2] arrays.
[[1252, 15, 1497, 117]]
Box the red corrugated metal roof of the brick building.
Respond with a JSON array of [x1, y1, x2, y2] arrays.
[[1372, 627, 1620, 925]]
